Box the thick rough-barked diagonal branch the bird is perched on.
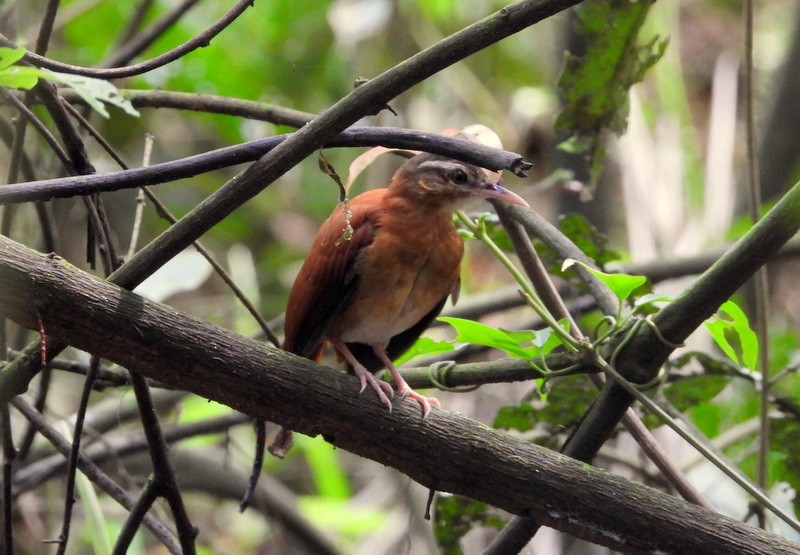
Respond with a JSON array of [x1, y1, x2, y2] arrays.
[[0, 237, 798, 554]]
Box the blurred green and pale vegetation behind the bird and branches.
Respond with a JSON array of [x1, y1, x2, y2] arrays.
[[0, 0, 800, 553]]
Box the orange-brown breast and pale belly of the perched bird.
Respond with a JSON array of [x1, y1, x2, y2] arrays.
[[329, 215, 464, 344]]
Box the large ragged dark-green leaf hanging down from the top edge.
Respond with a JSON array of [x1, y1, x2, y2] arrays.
[[556, 0, 667, 195]]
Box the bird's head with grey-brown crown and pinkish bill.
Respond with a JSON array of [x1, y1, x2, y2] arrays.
[[389, 153, 528, 208]]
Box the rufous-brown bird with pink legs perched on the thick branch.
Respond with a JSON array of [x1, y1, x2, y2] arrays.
[[283, 154, 527, 418]]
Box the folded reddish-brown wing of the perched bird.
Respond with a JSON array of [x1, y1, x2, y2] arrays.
[[283, 189, 386, 358]]
